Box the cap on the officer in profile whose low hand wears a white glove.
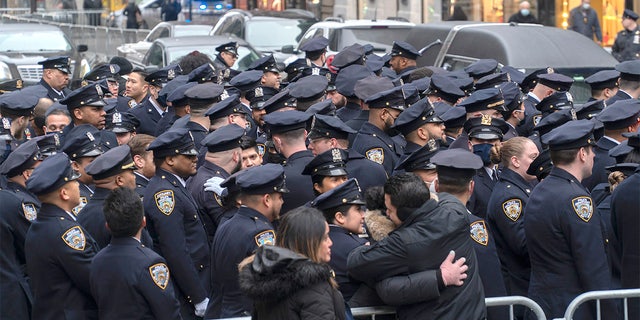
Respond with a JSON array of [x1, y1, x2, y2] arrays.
[[147, 128, 198, 159]]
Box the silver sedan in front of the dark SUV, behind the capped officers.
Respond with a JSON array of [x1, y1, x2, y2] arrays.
[[131, 36, 261, 71]]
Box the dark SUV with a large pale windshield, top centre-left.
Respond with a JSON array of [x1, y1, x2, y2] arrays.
[[211, 9, 318, 63]]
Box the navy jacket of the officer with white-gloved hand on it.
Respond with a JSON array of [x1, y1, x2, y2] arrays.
[[187, 161, 229, 243]]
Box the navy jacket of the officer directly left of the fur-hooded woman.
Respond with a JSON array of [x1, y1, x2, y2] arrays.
[[205, 206, 274, 319]]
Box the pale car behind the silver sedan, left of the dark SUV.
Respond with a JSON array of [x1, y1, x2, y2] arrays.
[[117, 21, 213, 60]]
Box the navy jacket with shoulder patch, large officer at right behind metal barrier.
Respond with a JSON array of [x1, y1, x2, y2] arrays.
[[524, 167, 616, 319]]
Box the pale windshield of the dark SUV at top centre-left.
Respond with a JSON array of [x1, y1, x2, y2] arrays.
[[245, 19, 312, 50]]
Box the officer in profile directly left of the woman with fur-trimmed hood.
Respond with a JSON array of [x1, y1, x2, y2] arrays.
[[206, 164, 289, 319]]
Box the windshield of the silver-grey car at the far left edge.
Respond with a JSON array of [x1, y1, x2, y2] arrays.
[[0, 31, 71, 52]]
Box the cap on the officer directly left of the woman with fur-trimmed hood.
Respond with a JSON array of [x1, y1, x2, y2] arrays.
[[236, 163, 289, 194]]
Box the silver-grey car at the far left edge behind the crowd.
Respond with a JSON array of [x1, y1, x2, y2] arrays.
[[0, 23, 90, 88]]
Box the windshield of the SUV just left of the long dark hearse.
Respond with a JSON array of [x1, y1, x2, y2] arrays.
[[329, 26, 411, 51]]
